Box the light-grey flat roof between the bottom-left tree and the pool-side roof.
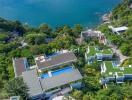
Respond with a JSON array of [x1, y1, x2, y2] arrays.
[[22, 69, 42, 96]]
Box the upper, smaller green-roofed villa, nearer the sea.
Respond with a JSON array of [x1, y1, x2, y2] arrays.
[[85, 46, 113, 64]]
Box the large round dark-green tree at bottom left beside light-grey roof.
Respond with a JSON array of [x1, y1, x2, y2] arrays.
[[5, 77, 29, 100]]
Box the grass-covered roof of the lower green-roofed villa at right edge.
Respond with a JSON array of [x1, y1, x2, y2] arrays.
[[103, 61, 132, 77]]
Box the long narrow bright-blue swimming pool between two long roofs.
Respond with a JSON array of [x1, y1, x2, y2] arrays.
[[40, 66, 73, 78]]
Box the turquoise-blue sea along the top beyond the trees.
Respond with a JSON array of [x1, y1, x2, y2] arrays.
[[0, 0, 121, 27]]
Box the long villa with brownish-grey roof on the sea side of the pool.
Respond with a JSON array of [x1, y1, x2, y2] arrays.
[[35, 50, 77, 72]]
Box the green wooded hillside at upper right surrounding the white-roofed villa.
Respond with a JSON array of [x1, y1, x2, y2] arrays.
[[98, 0, 132, 57]]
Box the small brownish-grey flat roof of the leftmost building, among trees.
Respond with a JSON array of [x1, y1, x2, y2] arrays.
[[13, 58, 27, 77]]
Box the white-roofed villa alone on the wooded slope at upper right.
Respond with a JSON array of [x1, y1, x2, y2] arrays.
[[108, 26, 128, 35]]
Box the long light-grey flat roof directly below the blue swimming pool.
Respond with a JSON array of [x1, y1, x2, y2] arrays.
[[41, 69, 82, 91]]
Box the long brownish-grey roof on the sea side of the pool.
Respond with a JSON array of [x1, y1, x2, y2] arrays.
[[36, 52, 77, 69]]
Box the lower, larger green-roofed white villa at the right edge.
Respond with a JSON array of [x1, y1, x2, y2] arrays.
[[100, 61, 132, 84]]
